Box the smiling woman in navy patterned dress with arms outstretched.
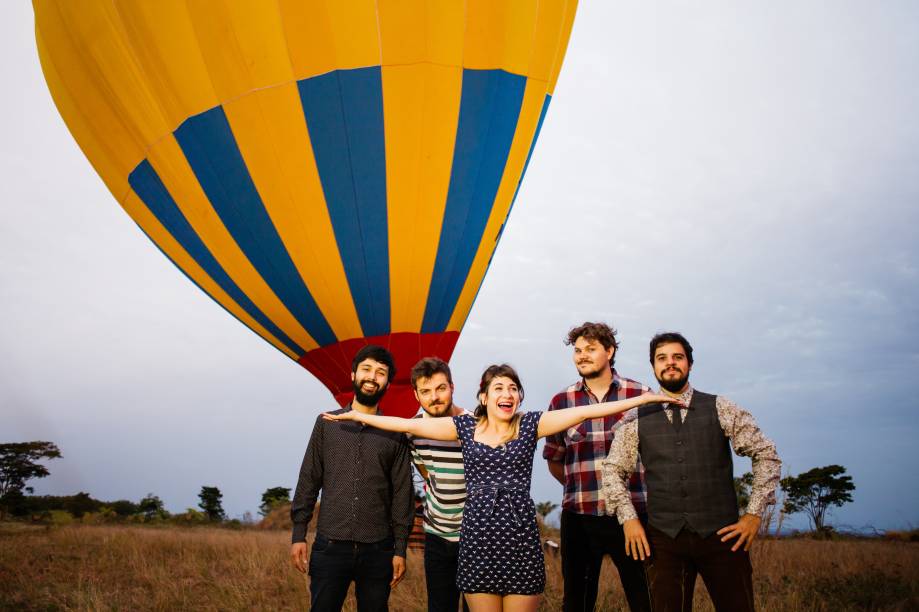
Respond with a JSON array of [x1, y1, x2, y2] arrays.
[[323, 364, 673, 611]]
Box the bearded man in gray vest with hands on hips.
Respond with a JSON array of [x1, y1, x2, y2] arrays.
[[601, 332, 782, 611]]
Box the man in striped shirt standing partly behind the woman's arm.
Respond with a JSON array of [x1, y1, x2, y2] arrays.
[[409, 357, 467, 612]]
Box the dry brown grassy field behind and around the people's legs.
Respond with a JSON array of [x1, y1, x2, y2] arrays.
[[0, 523, 919, 612]]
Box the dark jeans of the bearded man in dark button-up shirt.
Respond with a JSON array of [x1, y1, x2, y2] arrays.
[[310, 533, 393, 612]]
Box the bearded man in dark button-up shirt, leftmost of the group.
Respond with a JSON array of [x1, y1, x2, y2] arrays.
[[290, 346, 414, 611]]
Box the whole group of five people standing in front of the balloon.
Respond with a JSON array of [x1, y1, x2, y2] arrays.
[[291, 323, 781, 612]]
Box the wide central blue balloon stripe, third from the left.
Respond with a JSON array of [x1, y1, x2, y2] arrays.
[[297, 66, 391, 336]]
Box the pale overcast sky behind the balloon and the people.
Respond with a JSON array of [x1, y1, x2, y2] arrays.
[[0, 0, 919, 528]]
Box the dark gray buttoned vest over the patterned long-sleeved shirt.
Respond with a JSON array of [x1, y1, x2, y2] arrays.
[[638, 390, 737, 538]]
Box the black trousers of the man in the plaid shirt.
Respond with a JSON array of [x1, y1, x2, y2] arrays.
[[562, 510, 651, 612]]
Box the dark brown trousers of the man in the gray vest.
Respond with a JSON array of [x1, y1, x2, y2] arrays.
[[647, 525, 754, 612]]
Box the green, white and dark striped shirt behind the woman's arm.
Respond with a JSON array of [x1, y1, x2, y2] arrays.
[[409, 410, 469, 542]]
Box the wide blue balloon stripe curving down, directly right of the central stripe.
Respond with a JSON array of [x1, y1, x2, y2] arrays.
[[421, 69, 526, 333]]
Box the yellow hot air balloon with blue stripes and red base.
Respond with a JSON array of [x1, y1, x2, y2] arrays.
[[33, 0, 577, 415]]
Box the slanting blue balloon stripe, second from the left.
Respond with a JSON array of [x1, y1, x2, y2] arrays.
[[175, 106, 337, 346]]
